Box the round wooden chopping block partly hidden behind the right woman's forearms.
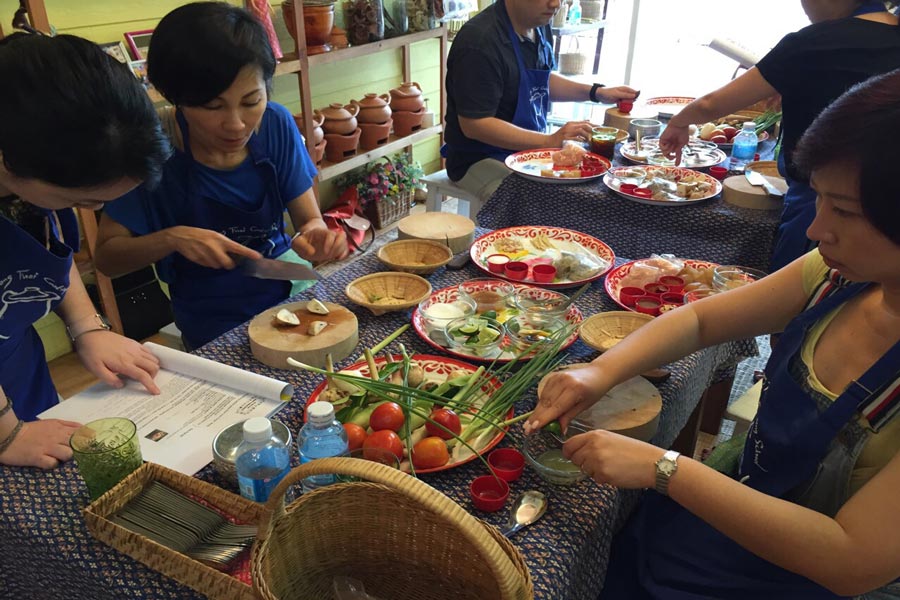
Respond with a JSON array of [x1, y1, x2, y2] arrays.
[[538, 364, 662, 442]]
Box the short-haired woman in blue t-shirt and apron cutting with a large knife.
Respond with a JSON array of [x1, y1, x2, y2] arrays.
[[97, 2, 347, 348]]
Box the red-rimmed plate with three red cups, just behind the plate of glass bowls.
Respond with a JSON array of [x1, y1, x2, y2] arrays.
[[469, 225, 616, 289]]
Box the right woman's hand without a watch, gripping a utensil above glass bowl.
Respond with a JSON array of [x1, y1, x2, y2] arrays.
[[525, 364, 608, 433]]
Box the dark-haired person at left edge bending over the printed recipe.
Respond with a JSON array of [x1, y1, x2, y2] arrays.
[[0, 34, 168, 468]]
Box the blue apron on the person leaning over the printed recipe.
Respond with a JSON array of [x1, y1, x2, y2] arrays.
[[0, 209, 78, 421]]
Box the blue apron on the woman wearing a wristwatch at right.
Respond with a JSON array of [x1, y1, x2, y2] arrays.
[[601, 284, 900, 600]]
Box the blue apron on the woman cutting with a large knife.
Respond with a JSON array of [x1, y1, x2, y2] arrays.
[[169, 112, 291, 348]]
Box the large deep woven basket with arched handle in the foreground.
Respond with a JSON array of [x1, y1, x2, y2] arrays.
[[251, 458, 534, 600]]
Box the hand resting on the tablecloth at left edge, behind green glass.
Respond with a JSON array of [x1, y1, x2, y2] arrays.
[[0, 419, 81, 469]]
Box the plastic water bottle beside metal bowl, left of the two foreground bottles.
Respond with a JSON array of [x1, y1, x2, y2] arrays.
[[235, 417, 291, 502]]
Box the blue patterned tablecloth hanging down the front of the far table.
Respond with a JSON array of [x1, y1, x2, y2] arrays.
[[478, 175, 781, 271]]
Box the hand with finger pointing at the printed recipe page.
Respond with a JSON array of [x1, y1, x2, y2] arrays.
[[75, 330, 159, 394]]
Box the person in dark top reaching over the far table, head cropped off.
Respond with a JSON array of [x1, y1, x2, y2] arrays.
[[660, 0, 900, 271]]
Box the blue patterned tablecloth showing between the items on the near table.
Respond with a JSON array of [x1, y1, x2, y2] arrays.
[[0, 230, 755, 600]]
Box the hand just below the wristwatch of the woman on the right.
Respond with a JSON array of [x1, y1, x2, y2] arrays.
[[563, 429, 663, 489]]
